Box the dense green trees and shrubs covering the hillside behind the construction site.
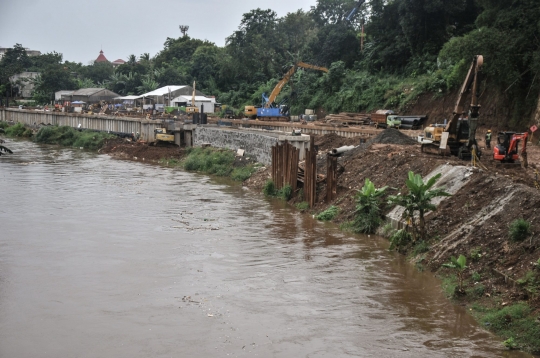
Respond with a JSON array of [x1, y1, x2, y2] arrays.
[[0, 0, 540, 124]]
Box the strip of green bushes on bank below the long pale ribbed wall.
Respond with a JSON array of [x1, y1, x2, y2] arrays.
[[35, 126, 115, 150]]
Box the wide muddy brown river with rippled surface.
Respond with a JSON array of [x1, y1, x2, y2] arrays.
[[0, 141, 530, 358]]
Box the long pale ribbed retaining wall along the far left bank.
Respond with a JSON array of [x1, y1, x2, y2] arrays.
[[0, 108, 161, 142]]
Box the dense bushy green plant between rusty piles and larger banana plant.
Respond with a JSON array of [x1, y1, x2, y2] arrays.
[[353, 178, 388, 234]]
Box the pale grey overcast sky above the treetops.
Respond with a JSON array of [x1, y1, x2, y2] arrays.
[[0, 0, 316, 65]]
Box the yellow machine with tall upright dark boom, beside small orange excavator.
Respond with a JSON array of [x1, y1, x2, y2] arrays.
[[419, 55, 484, 159]]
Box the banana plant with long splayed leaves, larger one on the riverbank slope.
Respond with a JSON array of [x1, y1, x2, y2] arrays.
[[388, 171, 450, 241]]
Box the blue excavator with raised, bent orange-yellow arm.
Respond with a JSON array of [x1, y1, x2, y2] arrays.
[[244, 61, 328, 121]]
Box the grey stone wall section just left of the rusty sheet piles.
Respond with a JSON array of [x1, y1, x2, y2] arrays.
[[193, 126, 278, 165]]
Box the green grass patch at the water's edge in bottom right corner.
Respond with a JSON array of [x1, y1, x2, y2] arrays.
[[473, 302, 540, 352]]
